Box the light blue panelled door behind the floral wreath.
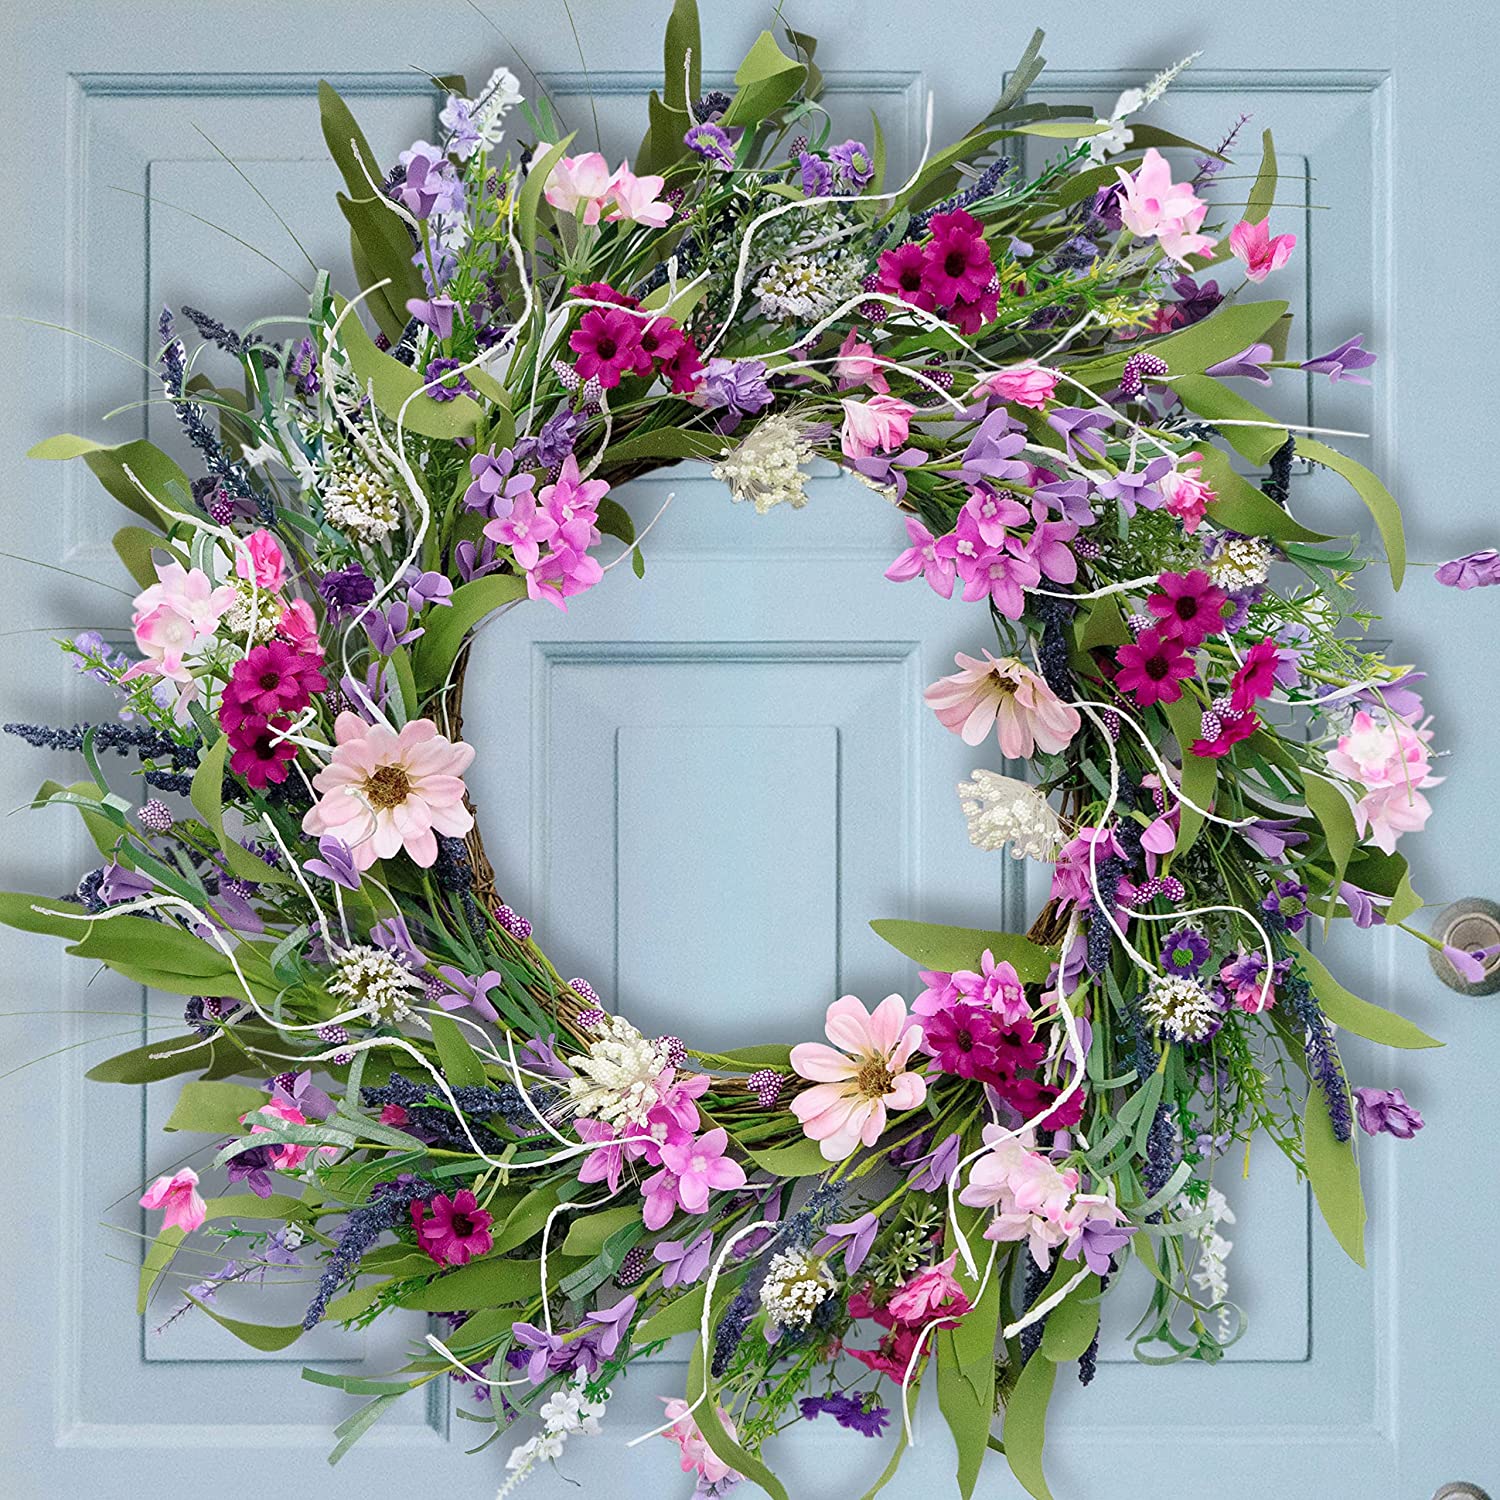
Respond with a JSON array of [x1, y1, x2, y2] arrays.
[[0, 0, 1500, 1500]]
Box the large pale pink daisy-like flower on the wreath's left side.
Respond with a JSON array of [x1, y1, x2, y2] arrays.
[[302, 711, 474, 870]]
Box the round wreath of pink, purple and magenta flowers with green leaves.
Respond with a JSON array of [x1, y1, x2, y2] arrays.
[[0, 0, 1493, 1496]]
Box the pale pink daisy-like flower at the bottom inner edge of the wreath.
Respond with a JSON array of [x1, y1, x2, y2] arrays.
[[792, 995, 927, 1161]]
